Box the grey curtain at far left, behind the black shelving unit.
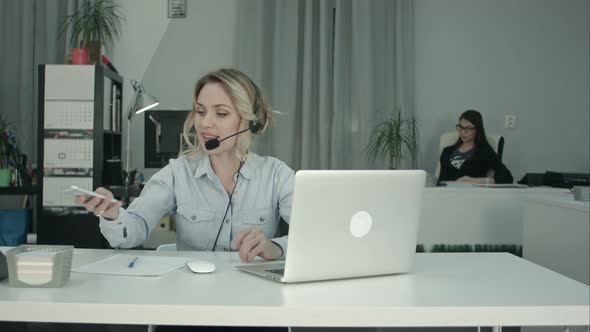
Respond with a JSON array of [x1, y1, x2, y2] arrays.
[[0, 0, 71, 165]]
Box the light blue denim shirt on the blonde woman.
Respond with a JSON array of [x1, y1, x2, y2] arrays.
[[99, 153, 294, 255]]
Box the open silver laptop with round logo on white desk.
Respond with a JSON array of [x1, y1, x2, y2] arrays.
[[237, 170, 426, 283]]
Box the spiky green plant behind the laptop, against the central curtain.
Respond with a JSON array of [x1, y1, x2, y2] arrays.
[[365, 107, 418, 169]]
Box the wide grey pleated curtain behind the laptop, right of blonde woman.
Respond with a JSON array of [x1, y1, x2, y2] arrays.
[[234, 0, 414, 169]]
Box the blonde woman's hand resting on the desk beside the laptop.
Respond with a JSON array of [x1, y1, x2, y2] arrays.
[[232, 227, 283, 262]]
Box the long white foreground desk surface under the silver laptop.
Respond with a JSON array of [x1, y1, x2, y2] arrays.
[[0, 252, 590, 327]]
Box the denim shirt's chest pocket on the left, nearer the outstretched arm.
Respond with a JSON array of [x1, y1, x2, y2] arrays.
[[176, 204, 215, 250]]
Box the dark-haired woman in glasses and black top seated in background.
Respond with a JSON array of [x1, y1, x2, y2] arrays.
[[438, 110, 513, 183]]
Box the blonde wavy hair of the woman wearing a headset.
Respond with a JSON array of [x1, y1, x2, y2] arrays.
[[179, 68, 272, 161]]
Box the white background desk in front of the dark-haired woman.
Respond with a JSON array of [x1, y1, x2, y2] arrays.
[[418, 187, 571, 249]]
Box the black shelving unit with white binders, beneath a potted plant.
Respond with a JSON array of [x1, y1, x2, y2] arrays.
[[37, 65, 123, 248]]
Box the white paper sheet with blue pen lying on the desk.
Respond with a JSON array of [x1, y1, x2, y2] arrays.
[[72, 254, 190, 277]]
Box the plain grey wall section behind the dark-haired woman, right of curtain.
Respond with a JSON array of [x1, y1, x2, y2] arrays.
[[415, 0, 590, 179]]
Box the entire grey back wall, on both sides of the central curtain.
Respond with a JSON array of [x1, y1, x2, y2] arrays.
[[111, 0, 590, 182]]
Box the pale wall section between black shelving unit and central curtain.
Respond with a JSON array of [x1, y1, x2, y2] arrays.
[[110, 0, 237, 178]]
